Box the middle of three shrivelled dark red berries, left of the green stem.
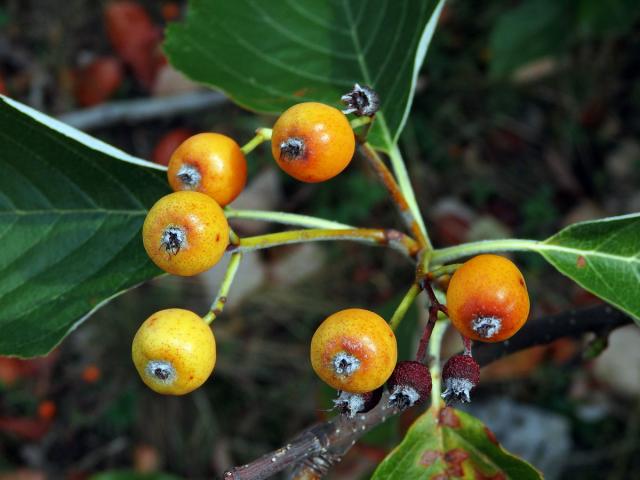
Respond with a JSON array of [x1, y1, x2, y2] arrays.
[[387, 360, 431, 410]]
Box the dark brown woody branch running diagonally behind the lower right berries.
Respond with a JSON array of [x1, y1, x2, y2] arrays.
[[224, 305, 632, 480]]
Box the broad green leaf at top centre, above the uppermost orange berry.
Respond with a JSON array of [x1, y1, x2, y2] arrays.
[[164, 0, 444, 151]]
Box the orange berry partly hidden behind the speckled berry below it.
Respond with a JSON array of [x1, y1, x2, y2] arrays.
[[167, 133, 247, 207]]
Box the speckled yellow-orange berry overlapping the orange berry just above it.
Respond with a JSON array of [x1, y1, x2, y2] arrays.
[[142, 191, 229, 276]]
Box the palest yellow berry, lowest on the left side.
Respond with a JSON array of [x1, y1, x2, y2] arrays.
[[131, 308, 216, 395]]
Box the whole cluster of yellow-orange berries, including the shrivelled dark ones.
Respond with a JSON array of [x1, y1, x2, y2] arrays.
[[132, 85, 529, 416]]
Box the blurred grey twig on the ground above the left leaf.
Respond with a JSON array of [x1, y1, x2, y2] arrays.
[[58, 91, 227, 130]]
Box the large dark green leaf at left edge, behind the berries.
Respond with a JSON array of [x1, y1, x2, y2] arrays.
[[0, 97, 168, 357]]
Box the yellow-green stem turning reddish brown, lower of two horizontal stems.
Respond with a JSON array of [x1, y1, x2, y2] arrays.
[[228, 228, 420, 259]]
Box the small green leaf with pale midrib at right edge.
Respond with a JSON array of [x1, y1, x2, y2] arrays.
[[537, 213, 640, 321]]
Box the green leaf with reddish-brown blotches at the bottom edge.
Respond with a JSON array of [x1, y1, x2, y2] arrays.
[[372, 407, 542, 480]]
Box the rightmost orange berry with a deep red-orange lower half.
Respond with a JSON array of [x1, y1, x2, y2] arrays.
[[447, 254, 529, 342]]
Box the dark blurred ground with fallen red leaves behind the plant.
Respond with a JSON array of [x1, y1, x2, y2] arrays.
[[0, 0, 640, 480]]
